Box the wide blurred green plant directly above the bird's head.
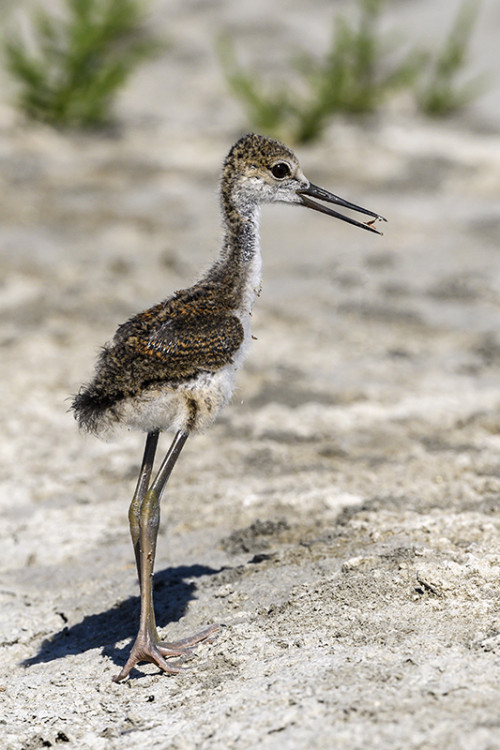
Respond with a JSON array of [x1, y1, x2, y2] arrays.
[[219, 0, 422, 142]]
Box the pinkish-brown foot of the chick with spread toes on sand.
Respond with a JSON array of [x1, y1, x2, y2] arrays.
[[113, 625, 219, 682]]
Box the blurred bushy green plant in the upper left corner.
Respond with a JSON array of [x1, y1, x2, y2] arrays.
[[3, 0, 161, 127]]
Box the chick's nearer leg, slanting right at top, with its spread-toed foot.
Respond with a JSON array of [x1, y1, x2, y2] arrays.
[[113, 431, 217, 682]]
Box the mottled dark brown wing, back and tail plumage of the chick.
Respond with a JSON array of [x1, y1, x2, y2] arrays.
[[73, 283, 244, 432]]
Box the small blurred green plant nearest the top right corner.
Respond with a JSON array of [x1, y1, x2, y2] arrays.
[[417, 0, 484, 117]]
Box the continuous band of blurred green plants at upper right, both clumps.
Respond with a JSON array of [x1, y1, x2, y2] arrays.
[[218, 0, 482, 143]]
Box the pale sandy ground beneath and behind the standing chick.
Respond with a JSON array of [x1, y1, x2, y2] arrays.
[[0, 0, 500, 750]]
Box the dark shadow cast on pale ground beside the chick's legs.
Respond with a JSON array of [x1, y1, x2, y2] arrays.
[[21, 565, 222, 667]]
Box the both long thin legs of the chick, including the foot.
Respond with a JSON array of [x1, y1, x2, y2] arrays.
[[113, 431, 217, 682]]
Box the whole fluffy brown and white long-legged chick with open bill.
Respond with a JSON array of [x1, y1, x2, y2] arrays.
[[72, 134, 382, 682]]
